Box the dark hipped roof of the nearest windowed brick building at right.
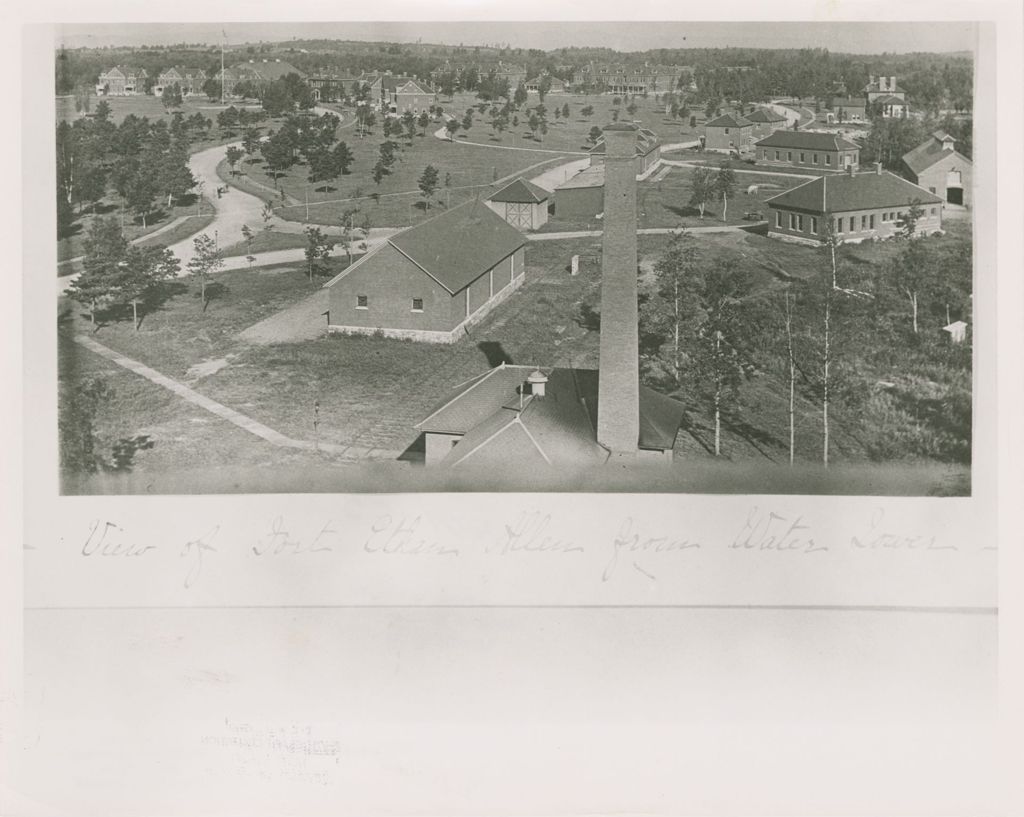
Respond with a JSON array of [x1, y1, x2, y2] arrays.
[[765, 171, 942, 213]]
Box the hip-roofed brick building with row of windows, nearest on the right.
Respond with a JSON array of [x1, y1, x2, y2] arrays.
[[765, 162, 942, 245]]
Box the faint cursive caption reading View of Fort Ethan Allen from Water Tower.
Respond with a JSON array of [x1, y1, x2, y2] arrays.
[[72, 505, 974, 590]]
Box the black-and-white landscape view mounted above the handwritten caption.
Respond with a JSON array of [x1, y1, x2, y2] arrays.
[[53, 22, 984, 496]]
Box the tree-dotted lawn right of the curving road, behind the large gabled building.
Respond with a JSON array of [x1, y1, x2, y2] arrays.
[[220, 131, 568, 226]]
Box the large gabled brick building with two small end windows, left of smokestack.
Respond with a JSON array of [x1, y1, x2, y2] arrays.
[[325, 201, 526, 343]]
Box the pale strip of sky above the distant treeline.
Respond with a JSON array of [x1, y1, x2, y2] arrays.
[[56, 20, 977, 54]]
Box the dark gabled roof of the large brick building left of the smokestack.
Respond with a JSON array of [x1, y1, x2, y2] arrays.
[[324, 200, 526, 295]]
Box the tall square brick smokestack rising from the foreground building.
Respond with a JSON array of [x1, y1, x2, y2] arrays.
[[597, 122, 640, 457]]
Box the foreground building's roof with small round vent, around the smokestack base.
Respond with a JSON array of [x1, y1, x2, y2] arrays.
[[416, 364, 683, 465]]
